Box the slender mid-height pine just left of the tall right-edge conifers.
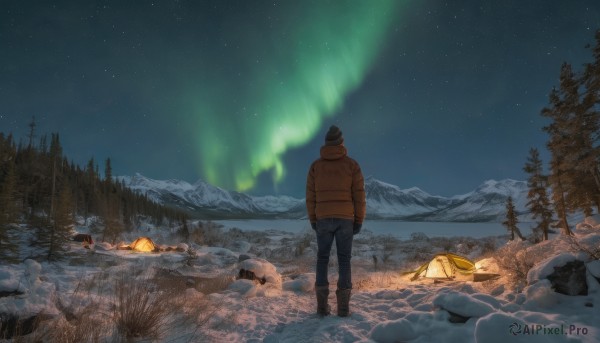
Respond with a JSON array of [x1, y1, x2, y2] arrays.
[[523, 148, 552, 240]]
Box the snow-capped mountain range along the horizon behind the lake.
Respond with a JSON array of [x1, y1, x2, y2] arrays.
[[117, 174, 528, 222]]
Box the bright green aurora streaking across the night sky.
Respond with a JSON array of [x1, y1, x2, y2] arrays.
[[188, 0, 399, 191]]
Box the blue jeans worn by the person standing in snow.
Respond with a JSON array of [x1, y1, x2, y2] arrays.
[[315, 218, 354, 289]]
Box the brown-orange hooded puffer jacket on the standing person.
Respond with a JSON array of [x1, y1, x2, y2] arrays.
[[306, 145, 366, 223]]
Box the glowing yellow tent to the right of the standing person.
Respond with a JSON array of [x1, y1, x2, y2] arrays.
[[411, 253, 475, 281]]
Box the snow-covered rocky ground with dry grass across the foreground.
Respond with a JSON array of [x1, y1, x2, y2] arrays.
[[0, 219, 600, 343]]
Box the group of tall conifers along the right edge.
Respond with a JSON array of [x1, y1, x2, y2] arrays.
[[504, 30, 600, 240]]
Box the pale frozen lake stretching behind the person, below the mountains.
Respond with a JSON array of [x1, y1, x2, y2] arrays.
[[215, 219, 531, 240]]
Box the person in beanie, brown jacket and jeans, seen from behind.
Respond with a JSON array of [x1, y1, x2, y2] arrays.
[[306, 125, 366, 317]]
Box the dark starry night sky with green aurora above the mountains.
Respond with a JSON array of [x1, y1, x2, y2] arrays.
[[0, 0, 600, 197]]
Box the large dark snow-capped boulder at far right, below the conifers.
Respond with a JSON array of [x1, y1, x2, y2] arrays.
[[548, 260, 588, 295]]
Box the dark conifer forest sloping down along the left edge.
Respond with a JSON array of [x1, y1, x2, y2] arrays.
[[0, 120, 188, 261]]
